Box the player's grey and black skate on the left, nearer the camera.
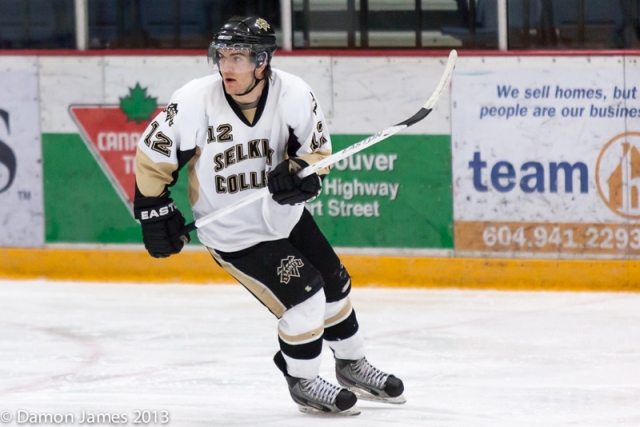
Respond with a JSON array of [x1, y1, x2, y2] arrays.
[[273, 352, 360, 416]]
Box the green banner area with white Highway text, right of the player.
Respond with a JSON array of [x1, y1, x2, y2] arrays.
[[307, 135, 453, 249]]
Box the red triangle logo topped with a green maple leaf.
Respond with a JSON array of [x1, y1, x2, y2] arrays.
[[69, 83, 162, 215]]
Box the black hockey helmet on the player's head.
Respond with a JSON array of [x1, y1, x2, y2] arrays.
[[207, 16, 277, 67]]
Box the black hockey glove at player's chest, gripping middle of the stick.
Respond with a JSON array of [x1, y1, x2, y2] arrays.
[[267, 159, 322, 205]]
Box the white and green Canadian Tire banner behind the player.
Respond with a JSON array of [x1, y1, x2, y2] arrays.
[[40, 57, 453, 249]]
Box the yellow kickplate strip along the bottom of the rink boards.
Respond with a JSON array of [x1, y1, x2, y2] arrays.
[[0, 248, 640, 292]]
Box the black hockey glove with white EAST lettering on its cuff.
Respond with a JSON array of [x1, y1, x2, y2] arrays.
[[133, 197, 191, 258]]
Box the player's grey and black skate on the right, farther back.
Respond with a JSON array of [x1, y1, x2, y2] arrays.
[[336, 357, 407, 404]]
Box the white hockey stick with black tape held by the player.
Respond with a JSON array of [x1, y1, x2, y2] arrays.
[[183, 50, 458, 233]]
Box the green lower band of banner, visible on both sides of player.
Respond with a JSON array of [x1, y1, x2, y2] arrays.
[[42, 133, 453, 249]]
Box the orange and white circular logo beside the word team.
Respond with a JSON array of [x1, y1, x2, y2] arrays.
[[596, 132, 640, 219]]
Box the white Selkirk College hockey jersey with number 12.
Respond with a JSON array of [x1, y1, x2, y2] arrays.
[[136, 70, 331, 252]]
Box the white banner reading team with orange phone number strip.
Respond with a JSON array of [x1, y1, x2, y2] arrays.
[[451, 57, 640, 258]]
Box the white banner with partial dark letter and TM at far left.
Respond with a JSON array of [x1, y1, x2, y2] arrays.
[[0, 57, 44, 247]]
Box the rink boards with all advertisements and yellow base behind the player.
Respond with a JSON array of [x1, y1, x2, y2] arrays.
[[0, 54, 640, 290]]
